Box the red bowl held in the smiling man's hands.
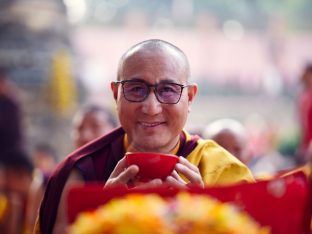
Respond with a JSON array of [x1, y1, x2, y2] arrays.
[[126, 152, 179, 181]]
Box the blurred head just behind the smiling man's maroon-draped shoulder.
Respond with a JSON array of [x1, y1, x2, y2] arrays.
[[72, 104, 117, 148]]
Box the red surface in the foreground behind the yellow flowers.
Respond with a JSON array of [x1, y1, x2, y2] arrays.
[[68, 172, 311, 234]]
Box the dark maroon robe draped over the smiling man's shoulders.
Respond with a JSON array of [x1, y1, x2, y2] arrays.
[[39, 128, 199, 234]]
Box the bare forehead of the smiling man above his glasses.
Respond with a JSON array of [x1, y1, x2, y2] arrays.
[[120, 48, 187, 81]]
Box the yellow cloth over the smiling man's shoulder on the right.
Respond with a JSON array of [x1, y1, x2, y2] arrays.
[[187, 139, 254, 186]]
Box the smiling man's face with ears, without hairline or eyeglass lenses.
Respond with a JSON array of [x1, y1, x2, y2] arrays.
[[112, 51, 196, 152]]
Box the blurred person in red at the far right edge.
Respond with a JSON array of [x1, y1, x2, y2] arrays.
[[298, 64, 312, 164]]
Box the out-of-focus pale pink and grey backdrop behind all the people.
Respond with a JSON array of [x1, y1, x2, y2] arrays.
[[0, 0, 312, 159]]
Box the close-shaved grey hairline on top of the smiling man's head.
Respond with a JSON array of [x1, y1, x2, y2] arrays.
[[117, 39, 190, 80]]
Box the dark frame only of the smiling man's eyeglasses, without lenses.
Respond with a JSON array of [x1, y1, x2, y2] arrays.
[[114, 80, 192, 104]]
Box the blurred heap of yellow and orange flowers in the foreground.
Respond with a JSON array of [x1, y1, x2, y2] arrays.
[[69, 192, 270, 234]]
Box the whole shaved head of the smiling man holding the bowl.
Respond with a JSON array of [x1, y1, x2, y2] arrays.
[[111, 39, 197, 152]]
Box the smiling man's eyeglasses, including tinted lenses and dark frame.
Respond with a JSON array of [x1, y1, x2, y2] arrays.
[[115, 80, 190, 104]]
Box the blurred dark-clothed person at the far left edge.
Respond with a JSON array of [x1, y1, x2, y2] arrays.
[[0, 68, 28, 234]]
